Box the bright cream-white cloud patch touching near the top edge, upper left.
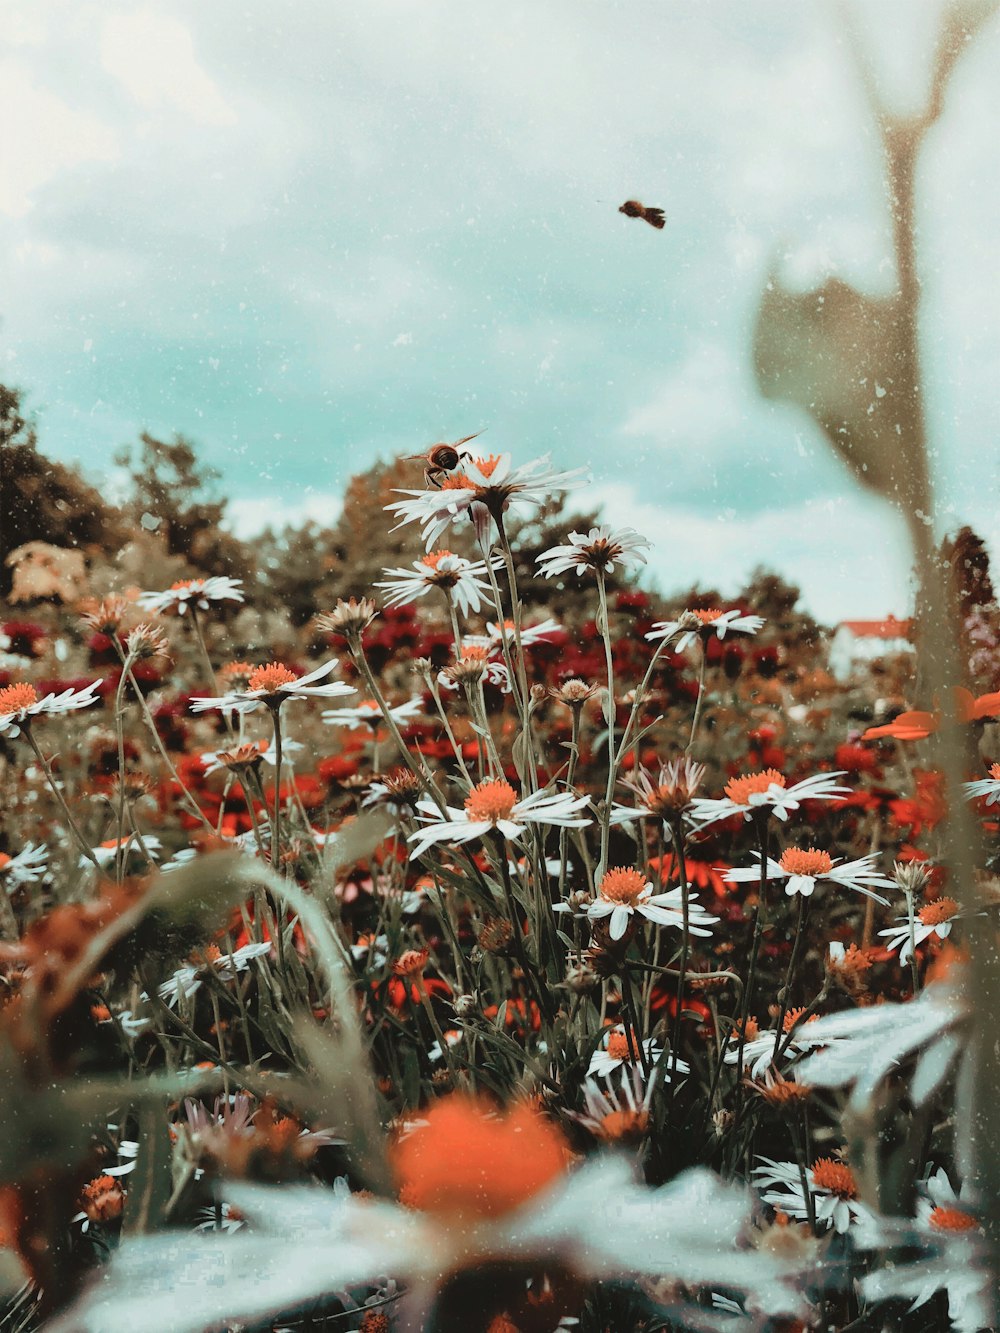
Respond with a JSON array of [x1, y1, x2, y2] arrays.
[[101, 8, 237, 125]]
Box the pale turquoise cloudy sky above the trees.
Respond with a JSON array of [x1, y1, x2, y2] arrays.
[[0, 0, 1000, 623]]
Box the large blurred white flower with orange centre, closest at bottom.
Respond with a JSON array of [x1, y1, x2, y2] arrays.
[[51, 1097, 795, 1333]]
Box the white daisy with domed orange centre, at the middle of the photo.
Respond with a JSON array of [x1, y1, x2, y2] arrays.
[[409, 780, 591, 860]]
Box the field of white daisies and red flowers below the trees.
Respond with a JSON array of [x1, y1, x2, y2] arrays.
[[0, 439, 1000, 1333]]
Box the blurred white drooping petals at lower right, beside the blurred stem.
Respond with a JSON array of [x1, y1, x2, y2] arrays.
[[796, 985, 967, 1112]]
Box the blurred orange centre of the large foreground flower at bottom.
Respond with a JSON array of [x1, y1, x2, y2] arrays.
[[392, 1094, 569, 1220]]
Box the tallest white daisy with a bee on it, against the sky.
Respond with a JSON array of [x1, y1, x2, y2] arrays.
[[385, 453, 583, 551]]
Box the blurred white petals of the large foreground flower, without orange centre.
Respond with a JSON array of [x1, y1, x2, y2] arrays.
[[49, 1157, 791, 1333]]
